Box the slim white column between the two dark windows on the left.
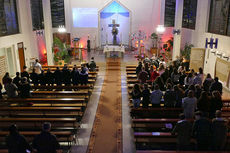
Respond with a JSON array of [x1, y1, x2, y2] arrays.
[[42, 0, 54, 65]]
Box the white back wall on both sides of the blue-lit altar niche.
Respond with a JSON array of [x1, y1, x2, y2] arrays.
[[65, 0, 165, 47]]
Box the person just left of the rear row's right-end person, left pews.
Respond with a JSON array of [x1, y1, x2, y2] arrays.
[[5, 78, 18, 98]]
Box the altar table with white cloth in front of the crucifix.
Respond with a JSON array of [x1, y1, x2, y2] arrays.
[[103, 45, 125, 57]]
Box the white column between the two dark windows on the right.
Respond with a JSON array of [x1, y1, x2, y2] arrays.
[[172, 0, 184, 60]]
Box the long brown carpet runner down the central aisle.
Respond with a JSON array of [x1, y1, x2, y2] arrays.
[[88, 59, 122, 153]]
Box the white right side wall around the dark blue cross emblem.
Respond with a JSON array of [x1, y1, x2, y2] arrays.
[[181, 0, 230, 87]]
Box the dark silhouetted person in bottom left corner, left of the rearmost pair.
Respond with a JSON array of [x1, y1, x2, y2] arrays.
[[6, 124, 32, 153]]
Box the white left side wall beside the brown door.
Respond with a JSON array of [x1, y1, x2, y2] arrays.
[[0, 0, 38, 71]]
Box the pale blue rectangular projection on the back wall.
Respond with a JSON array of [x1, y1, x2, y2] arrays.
[[72, 8, 98, 28]]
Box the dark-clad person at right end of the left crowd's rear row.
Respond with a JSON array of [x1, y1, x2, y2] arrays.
[[19, 77, 31, 98]]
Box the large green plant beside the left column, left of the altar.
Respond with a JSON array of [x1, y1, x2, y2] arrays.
[[52, 37, 71, 65]]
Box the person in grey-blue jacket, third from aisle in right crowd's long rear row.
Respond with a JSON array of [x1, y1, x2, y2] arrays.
[[150, 84, 163, 107]]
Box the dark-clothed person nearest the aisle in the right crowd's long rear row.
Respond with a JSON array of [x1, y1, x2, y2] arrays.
[[132, 84, 142, 108]]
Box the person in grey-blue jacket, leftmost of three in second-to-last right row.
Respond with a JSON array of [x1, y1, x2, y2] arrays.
[[182, 90, 197, 119]]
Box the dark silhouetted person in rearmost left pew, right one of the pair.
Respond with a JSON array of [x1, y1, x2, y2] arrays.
[[32, 122, 61, 153]]
